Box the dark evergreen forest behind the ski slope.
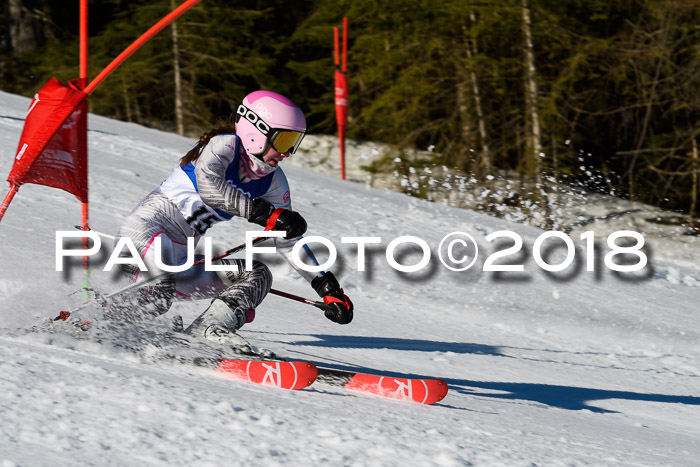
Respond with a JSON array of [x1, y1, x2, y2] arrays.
[[0, 0, 700, 216]]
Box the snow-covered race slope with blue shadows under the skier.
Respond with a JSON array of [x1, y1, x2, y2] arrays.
[[0, 92, 700, 467]]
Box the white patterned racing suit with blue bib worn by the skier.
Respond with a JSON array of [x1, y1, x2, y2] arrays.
[[117, 134, 318, 324]]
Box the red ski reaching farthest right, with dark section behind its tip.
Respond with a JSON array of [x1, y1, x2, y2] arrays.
[[318, 368, 448, 404]]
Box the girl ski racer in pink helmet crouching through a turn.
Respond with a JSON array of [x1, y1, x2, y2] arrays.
[[117, 91, 353, 346]]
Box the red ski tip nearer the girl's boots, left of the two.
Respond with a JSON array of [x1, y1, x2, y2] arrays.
[[216, 360, 318, 389]]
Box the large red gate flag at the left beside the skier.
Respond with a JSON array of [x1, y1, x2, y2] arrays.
[[7, 78, 88, 203]]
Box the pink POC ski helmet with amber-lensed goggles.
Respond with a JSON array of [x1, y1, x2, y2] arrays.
[[236, 91, 306, 156]]
